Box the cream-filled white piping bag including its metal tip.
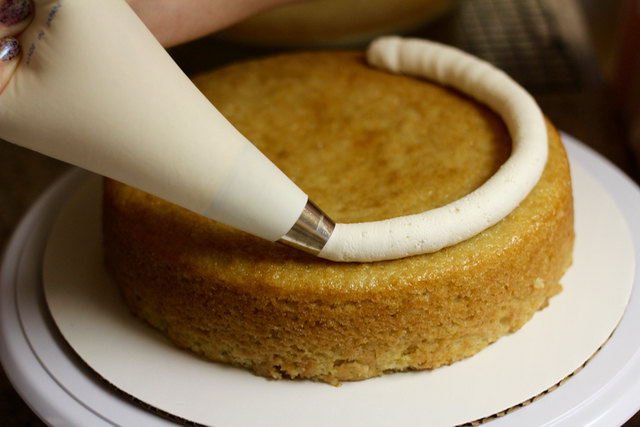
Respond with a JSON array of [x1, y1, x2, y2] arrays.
[[0, 0, 334, 255]]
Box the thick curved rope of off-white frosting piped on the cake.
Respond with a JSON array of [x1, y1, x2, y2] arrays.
[[318, 37, 549, 262]]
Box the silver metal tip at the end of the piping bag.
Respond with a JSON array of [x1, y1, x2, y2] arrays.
[[278, 200, 335, 255]]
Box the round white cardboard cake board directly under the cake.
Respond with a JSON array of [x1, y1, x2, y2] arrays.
[[44, 136, 636, 427]]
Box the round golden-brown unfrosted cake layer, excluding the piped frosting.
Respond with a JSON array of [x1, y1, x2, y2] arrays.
[[103, 51, 574, 384]]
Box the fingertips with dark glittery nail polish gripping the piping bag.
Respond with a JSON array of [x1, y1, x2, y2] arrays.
[[0, 0, 33, 93]]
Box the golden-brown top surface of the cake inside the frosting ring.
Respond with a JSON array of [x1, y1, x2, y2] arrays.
[[195, 52, 510, 223]]
